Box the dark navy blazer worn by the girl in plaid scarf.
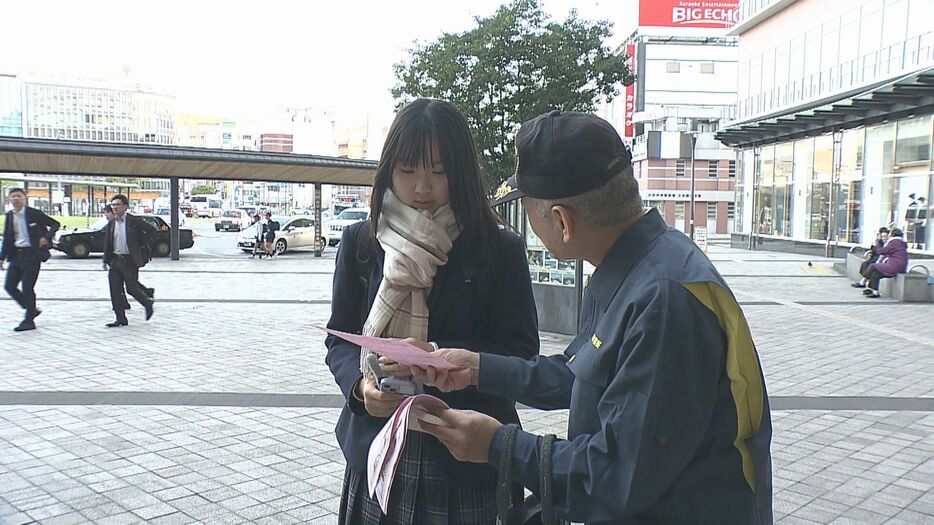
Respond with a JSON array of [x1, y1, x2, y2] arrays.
[[325, 222, 539, 484]]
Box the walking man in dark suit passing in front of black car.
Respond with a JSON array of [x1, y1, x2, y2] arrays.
[[104, 195, 156, 328]]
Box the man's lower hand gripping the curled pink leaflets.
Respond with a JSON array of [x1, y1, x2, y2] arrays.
[[419, 409, 503, 463]]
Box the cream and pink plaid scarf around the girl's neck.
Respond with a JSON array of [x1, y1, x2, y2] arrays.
[[360, 190, 460, 374]]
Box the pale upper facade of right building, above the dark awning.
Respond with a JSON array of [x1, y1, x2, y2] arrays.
[[737, 0, 934, 119]]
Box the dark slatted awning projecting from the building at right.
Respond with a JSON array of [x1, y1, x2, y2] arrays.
[[715, 68, 934, 148]]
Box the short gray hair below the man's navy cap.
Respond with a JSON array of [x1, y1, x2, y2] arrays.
[[526, 166, 642, 228]]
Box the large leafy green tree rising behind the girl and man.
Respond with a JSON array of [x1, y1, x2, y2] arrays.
[[392, 0, 635, 188]]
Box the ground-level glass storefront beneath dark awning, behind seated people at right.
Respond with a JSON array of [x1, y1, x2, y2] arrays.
[[734, 115, 934, 254]]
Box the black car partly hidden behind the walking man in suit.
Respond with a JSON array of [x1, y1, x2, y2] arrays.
[[52, 215, 195, 259]]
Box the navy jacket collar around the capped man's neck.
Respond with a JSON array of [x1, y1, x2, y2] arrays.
[[588, 208, 668, 309]]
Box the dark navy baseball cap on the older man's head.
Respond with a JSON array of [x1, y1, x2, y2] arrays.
[[492, 110, 632, 206]]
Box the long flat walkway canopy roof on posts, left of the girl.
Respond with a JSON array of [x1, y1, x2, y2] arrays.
[[0, 137, 376, 186]]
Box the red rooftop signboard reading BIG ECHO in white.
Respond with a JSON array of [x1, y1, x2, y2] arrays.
[[639, 0, 739, 28]]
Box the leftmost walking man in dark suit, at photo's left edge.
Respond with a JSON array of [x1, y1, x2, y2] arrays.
[[0, 188, 59, 332]]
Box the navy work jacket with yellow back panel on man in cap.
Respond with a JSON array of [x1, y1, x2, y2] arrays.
[[479, 209, 772, 525]]
